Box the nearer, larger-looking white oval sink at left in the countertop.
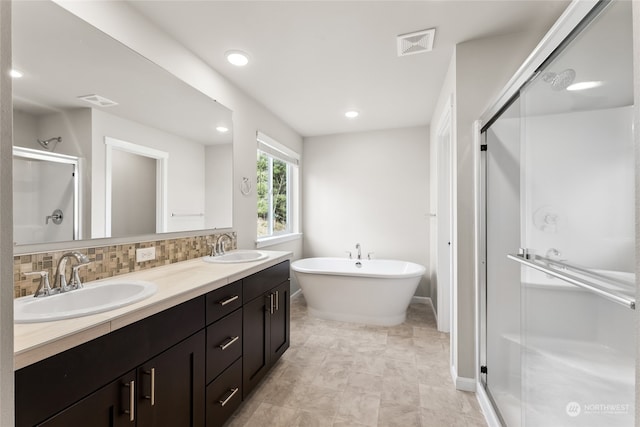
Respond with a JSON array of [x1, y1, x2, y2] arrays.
[[13, 280, 157, 323]]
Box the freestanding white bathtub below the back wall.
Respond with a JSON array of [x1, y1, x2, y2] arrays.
[[291, 258, 426, 326]]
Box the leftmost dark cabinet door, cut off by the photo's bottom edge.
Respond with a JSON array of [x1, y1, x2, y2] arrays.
[[34, 371, 137, 427]]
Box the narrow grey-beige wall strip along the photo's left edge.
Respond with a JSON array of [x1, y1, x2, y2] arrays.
[[0, 1, 14, 426]]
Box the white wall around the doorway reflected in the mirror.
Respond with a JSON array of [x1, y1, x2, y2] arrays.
[[91, 109, 205, 238]]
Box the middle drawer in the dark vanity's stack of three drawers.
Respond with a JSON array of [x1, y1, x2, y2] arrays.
[[207, 309, 242, 383]]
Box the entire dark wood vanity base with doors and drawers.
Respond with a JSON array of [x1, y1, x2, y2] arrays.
[[15, 261, 289, 427]]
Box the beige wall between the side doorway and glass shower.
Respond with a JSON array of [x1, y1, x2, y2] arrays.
[[431, 28, 560, 389]]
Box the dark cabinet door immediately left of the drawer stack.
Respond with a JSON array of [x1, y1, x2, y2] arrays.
[[137, 331, 205, 427]]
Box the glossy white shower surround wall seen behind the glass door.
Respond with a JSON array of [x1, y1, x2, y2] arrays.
[[522, 108, 635, 276]]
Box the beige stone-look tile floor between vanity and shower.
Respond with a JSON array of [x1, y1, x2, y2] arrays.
[[226, 294, 486, 427]]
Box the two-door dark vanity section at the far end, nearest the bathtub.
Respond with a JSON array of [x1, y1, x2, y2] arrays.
[[242, 262, 290, 397]]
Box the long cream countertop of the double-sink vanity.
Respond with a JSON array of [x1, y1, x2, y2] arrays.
[[14, 251, 292, 370]]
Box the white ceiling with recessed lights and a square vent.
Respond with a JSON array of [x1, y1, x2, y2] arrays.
[[130, 0, 569, 136]]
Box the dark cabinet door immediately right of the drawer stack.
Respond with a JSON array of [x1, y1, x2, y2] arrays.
[[242, 294, 270, 397]]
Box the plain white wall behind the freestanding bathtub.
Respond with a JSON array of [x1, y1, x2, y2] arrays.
[[302, 127, 430, 296]]
